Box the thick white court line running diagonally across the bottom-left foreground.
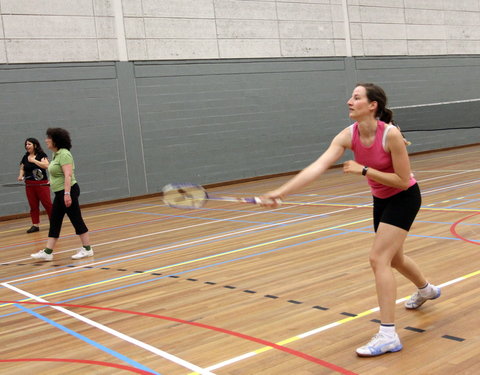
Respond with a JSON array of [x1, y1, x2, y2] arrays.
[[1, 283, 215, 375]]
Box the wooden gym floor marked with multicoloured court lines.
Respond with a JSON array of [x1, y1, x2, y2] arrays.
[[0, 145, 480, 375]]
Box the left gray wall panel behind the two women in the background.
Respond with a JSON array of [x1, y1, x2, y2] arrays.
[[0, 63, 129, 216]]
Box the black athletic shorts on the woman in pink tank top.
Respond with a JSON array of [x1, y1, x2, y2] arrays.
[[373, 184, 422, 232]]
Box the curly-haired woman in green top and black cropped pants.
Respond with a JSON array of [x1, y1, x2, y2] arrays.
[[31, 128, 93, 261]]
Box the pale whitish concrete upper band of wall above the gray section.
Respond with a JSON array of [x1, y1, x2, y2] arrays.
[[0, 0, 480, 64]]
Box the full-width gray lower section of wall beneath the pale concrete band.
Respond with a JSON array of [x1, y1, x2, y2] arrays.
[[0, 56, 480, 217]]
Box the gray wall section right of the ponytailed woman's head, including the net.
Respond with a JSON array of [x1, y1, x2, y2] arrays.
[[355, 56, 480, 152]]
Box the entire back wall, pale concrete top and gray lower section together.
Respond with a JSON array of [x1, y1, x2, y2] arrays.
[[0, 0, 480, 217]]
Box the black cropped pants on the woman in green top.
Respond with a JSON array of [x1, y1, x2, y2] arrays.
[[48, 184, 88, 238]]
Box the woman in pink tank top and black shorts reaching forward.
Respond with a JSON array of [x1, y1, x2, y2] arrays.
[[261, 83, 440, 357]]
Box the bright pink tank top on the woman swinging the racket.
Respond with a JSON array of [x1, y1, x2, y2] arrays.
[[351, 121, 417, 199]]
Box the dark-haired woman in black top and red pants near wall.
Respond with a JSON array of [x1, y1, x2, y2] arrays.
[[18, 138, 52, 233]]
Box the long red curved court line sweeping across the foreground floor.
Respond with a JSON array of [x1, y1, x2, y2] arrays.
[[0, 301, 358, 375]]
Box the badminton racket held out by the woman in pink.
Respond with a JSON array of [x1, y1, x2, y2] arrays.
[[161, 184, 280, 209]]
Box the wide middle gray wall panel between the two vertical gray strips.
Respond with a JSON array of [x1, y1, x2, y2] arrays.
[[135, 59, 346, 189]]
